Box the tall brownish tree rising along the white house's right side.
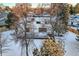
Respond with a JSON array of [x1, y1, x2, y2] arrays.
[[50, 3, 68, 37]]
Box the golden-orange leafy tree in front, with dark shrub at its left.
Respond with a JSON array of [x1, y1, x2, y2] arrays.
[[33, 38, 64, 56]]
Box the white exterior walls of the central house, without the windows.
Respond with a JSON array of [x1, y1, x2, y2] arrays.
[[27, 15, 56, 33]]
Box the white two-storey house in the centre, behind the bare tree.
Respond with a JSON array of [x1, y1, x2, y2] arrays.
[[19, 13, 56, 38]]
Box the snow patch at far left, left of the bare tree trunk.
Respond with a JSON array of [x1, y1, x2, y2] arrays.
[[2, 30, 20, 56]]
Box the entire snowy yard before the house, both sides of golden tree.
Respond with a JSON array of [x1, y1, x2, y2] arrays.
[[0, 30, 79, 56]]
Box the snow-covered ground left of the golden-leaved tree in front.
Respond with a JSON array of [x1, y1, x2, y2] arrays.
[[2, 30, 43, 56]]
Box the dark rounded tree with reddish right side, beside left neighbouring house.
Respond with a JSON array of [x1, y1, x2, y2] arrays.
[[5, 12, 19, 28]]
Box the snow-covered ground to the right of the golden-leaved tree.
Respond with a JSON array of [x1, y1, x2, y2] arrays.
[[64, 32, 79, 56]]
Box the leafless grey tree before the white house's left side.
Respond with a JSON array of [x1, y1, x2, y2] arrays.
[[12, 15, 34, 56]]
